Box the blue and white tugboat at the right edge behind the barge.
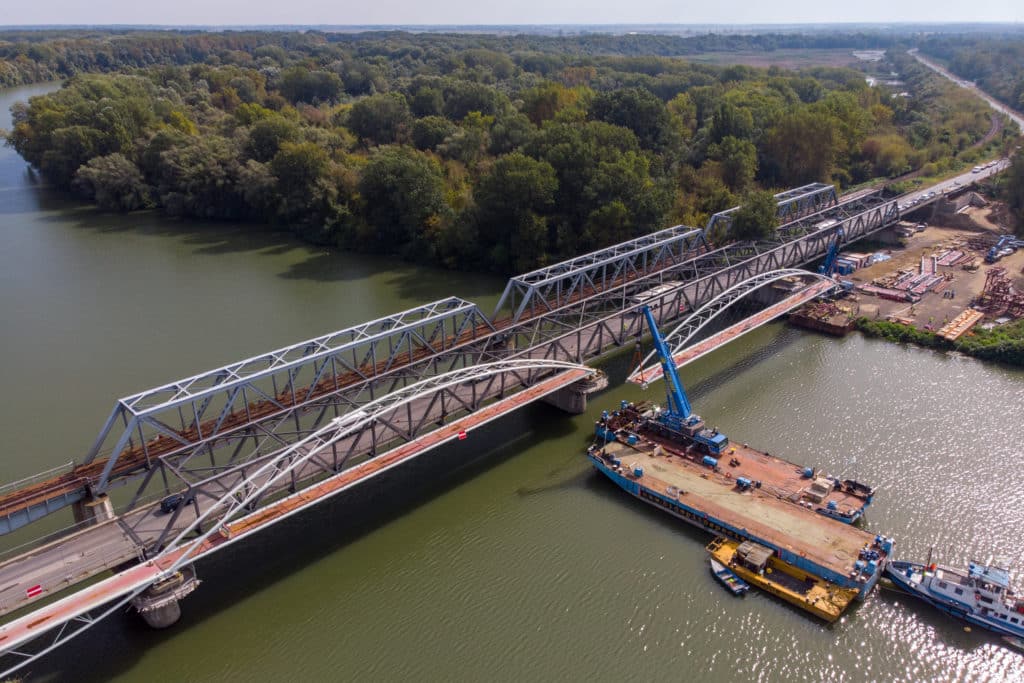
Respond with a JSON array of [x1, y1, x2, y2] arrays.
[[886, 561, 1024, 643]]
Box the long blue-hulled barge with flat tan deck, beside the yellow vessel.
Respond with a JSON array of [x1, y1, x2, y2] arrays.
[[587, 419, 892, 599]]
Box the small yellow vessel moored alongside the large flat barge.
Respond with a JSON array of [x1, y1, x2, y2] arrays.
[[708, 538, 857, 623]]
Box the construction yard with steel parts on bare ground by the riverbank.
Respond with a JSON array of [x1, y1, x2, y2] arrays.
[[791, 192, 1024, 359]]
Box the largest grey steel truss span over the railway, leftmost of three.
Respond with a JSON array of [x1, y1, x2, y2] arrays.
[[85, 297, 494, 493]]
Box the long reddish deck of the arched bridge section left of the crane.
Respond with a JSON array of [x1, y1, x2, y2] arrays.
[[0, 370, 589, 651]]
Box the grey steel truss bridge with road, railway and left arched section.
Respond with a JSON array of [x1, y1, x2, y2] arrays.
[[0, 180, 899, 666]]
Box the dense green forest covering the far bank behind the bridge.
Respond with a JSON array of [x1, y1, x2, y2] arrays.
[[0, 32, 1003, 273]]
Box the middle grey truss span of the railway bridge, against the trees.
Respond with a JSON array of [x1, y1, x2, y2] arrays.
[[494, 225, 708, 324]]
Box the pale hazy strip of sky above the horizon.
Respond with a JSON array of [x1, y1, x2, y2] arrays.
[[0, 0, 1024, 26]]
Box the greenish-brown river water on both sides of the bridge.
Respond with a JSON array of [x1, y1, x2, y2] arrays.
[[0, 85, 1024, 681]]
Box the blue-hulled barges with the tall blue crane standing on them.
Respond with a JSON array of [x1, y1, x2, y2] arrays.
[[587, 308, 893, 600]]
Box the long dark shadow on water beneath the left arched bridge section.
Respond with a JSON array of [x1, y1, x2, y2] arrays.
[[28, 403, 578, 683]]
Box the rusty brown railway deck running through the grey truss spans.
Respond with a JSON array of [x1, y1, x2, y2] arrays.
[[0, 250, 702, 515]]
